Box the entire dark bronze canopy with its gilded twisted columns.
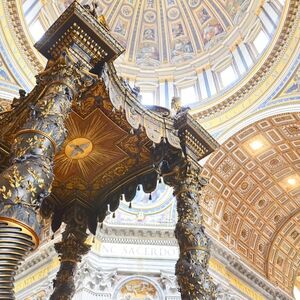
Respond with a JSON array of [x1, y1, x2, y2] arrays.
[[0, 1, 217, 300]]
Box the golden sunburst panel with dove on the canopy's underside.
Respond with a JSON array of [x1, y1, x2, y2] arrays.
[[55, 109, 127, 182]]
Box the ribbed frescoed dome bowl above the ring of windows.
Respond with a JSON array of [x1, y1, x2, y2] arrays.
[[54, 0, 251, 66]]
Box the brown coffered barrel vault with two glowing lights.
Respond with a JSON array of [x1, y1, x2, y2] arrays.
[[201, 113, 300, 293]]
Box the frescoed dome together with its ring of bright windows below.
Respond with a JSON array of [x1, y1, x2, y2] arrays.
[[23, 0, 288, 107]]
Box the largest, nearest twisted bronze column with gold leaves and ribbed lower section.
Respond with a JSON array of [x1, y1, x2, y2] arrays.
[[0, 53, 93, 300]]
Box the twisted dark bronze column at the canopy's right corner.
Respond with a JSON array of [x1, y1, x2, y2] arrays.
[[164, 162, 217, 300]]
